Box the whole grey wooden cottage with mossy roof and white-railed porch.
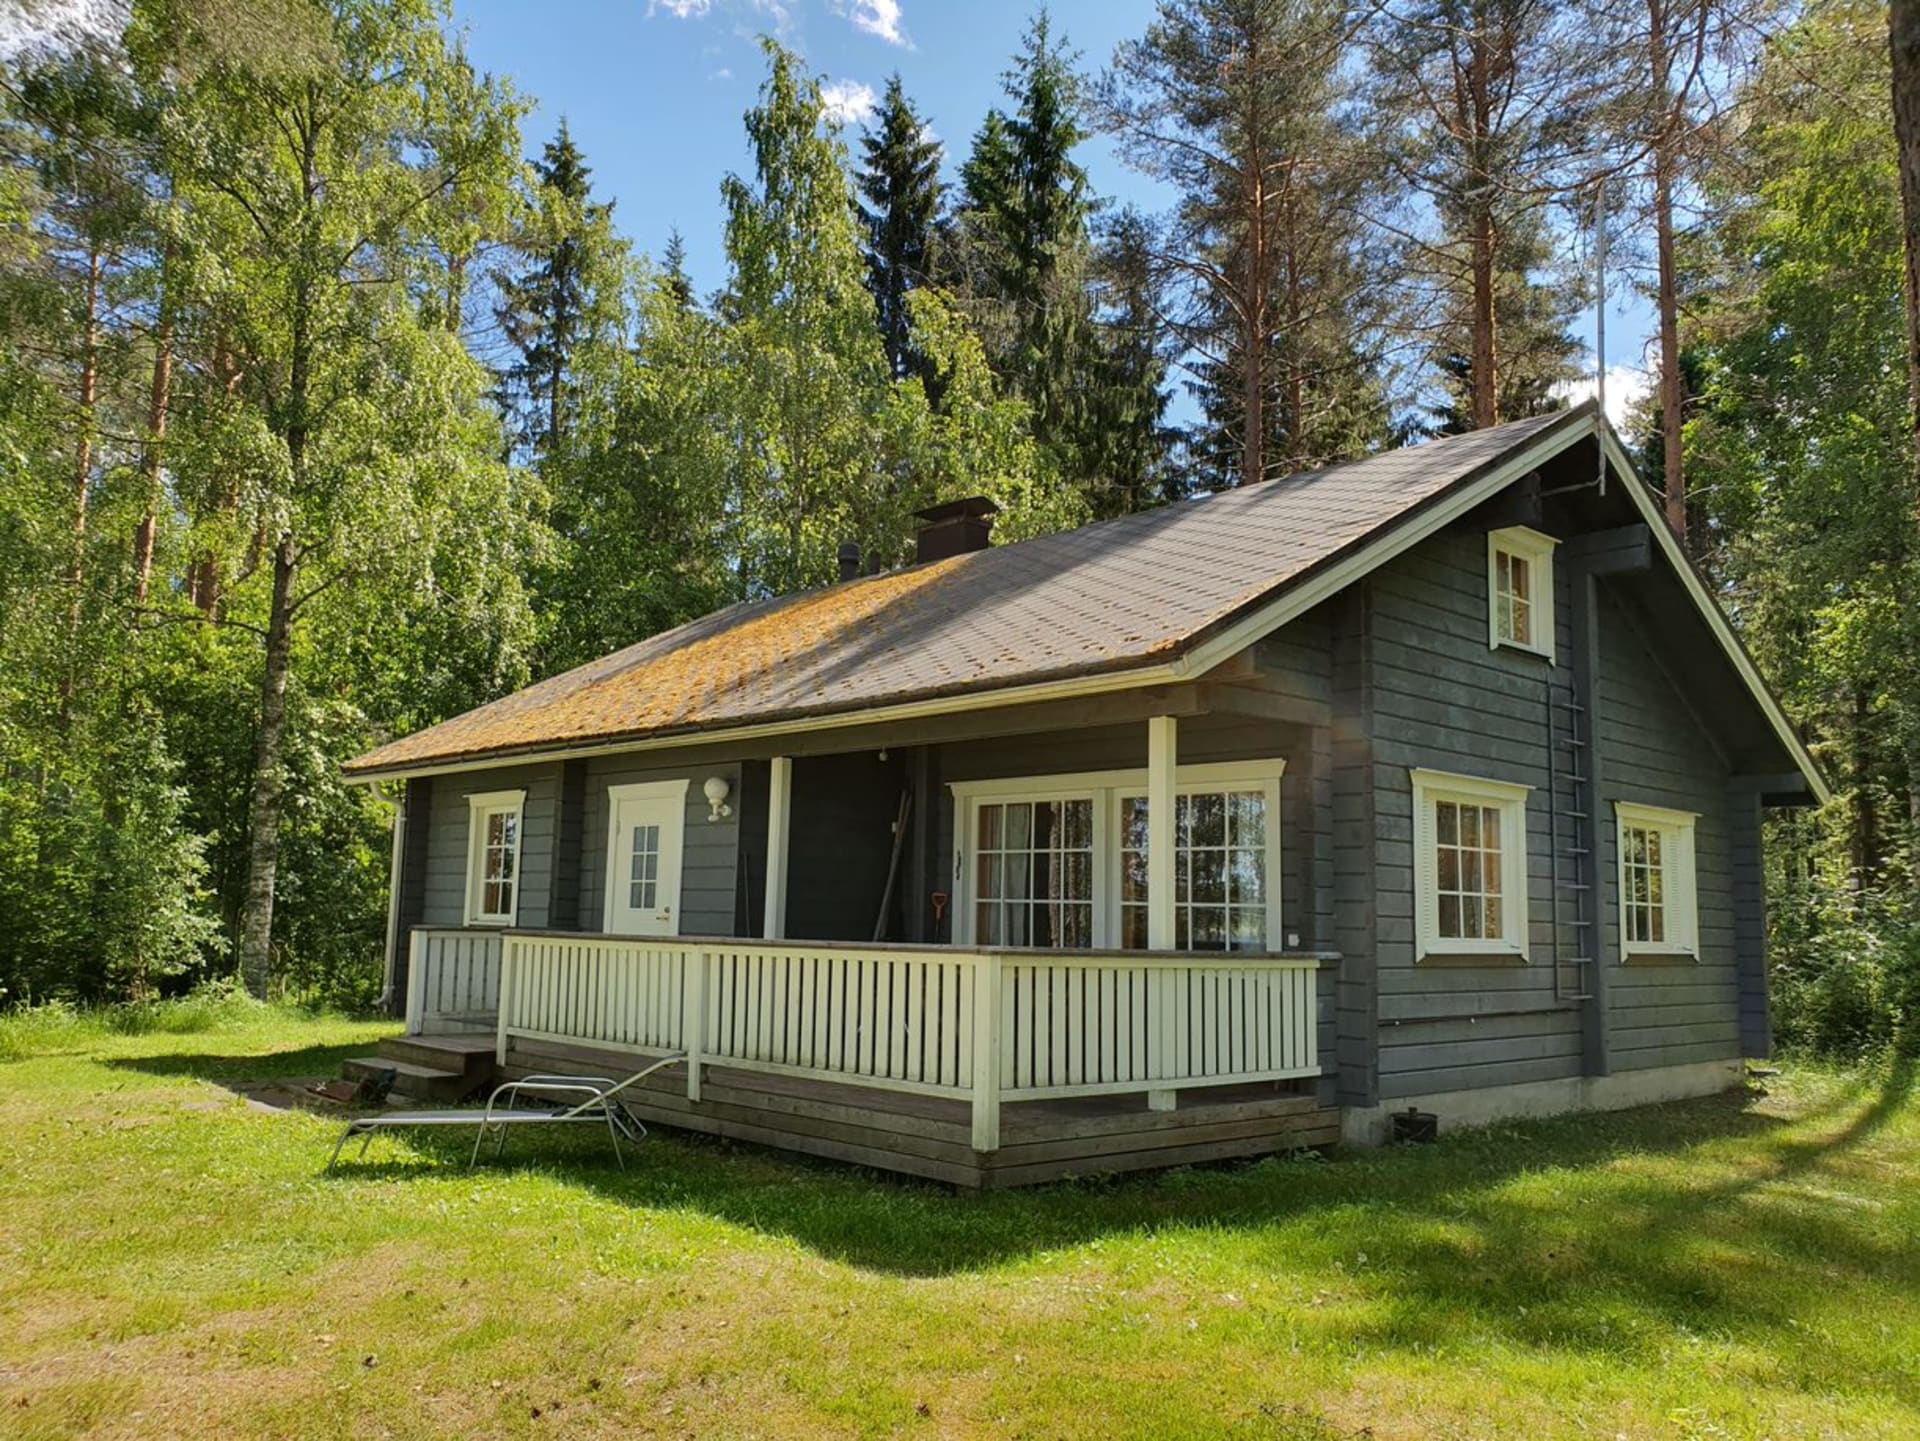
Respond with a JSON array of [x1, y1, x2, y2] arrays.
[[348, 407, 1826, 1186]]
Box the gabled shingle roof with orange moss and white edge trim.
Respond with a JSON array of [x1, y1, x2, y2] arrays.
[[346, 405, 1818, 805]]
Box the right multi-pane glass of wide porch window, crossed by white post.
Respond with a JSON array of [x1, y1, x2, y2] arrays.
[[1119, 787, 1269, 950]]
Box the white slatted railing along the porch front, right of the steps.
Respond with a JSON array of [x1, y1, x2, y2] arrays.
[[497, 934, 1319, 1151]]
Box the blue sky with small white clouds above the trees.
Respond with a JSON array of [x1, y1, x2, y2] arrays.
[[453, 0, 1647, 414]]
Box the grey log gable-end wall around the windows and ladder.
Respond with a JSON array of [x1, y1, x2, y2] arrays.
[[1367, 522, 1764, 1105]]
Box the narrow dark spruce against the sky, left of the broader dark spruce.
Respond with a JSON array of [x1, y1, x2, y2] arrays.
[[856, 75, 941, 384]]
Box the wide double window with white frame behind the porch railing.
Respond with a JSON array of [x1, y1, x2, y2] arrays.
[[952, 760, 1283, 950]]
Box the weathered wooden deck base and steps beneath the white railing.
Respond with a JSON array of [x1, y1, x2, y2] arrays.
[[501, 1036, 1340, 1190]]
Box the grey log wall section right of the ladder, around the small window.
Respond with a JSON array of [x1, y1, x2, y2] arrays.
[[1599, 583, 1759, 1071]]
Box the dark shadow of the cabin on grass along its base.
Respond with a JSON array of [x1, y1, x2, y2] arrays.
[[336, 1074, 1847, 1276]]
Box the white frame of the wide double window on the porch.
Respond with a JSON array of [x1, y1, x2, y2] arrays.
[[947, 756, 1286, 954]]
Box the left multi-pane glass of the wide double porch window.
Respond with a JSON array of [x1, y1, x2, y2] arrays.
[[973, 796, 1094, 950]]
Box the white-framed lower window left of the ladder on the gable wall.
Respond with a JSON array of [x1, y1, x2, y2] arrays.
[[1411, 769, 1526, 959]]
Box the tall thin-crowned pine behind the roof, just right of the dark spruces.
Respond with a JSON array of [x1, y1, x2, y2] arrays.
[[1100, 0, 1390, 485]]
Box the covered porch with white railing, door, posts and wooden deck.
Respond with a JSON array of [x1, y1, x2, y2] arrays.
[[387, 683, 1338, 1186]]
